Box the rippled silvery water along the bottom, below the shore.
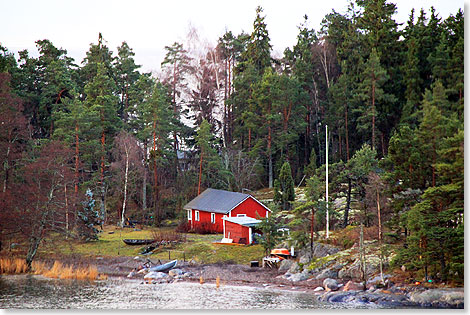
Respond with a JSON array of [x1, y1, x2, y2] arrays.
[[0, 275, 380, 309]]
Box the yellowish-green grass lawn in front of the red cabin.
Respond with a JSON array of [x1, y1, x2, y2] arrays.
[[40, 226, 264, 264]]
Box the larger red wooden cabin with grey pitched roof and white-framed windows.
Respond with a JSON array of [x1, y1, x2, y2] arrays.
[[183, 188, 271, 233]]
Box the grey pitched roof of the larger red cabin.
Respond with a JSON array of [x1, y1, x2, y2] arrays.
[[183, 188, 269, 213]]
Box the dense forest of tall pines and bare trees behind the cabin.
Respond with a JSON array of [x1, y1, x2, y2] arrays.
[[0, 0, 464, 281]]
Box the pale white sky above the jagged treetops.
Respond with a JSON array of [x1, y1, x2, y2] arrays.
[[0, 0, 466, 71]]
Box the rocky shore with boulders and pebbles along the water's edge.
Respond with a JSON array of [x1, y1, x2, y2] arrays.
[[81, 257, 464, 309]]
